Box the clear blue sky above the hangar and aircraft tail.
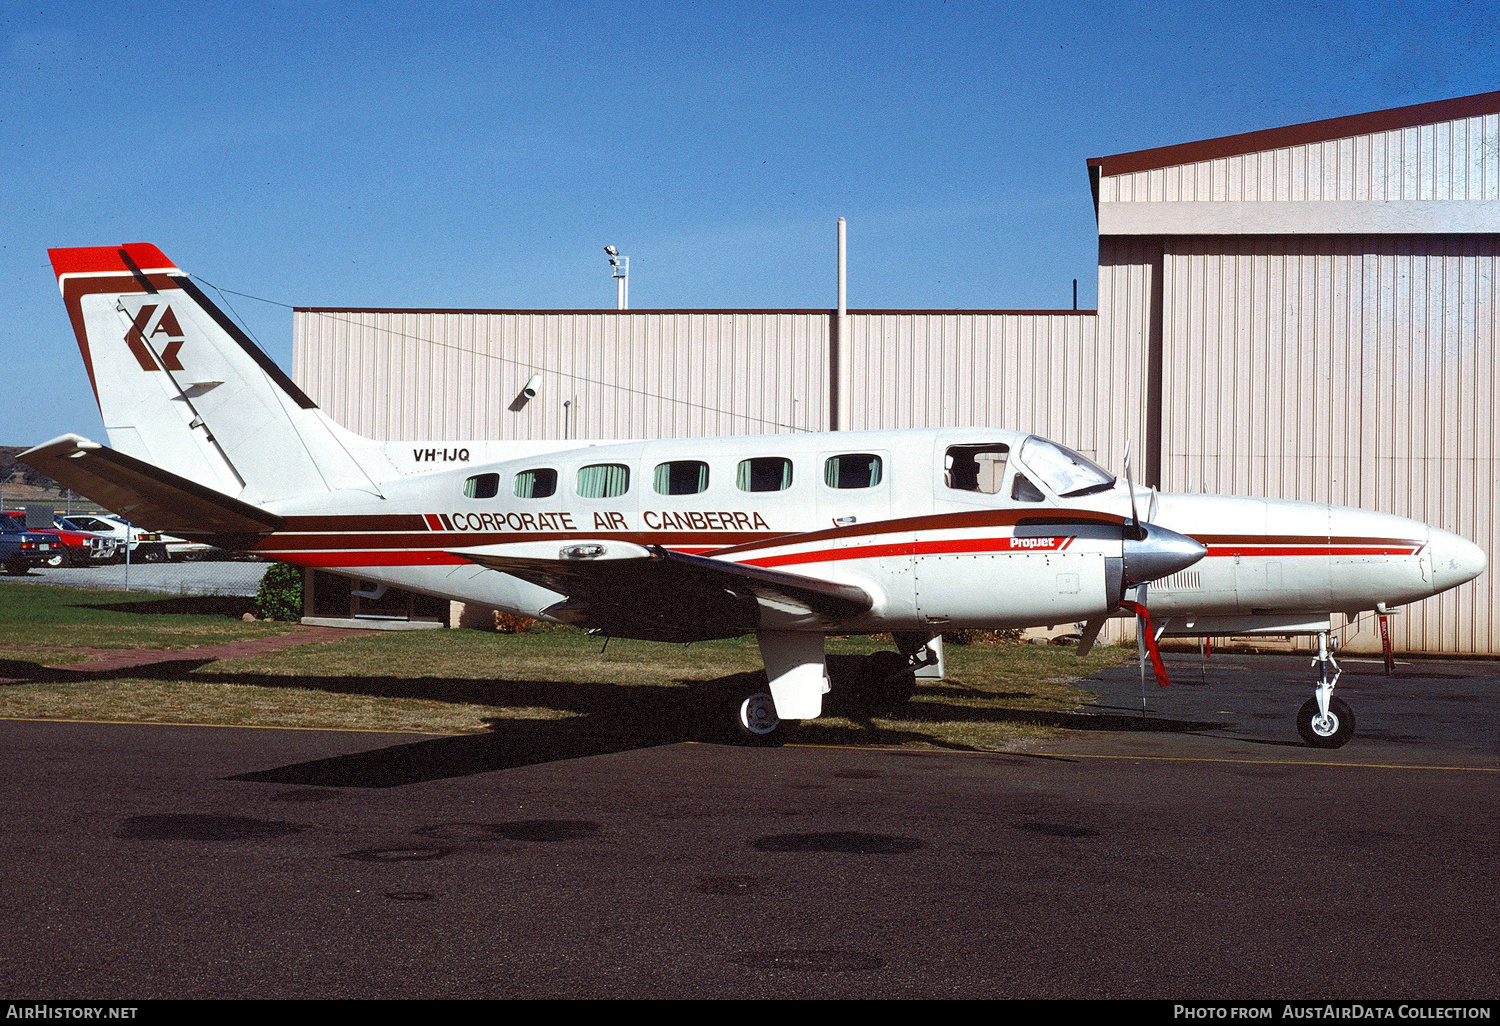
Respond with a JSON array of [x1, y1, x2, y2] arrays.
[[0, 0, 1500, 444]]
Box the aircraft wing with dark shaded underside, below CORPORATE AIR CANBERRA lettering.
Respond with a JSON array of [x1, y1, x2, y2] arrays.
[[455, 540, 875, 642]]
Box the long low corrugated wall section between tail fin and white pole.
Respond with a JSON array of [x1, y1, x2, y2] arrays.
[[293, 309, 830, 441]]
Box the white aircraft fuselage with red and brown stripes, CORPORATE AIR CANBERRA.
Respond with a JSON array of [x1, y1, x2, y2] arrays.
[[257, 428, 1484, 635]]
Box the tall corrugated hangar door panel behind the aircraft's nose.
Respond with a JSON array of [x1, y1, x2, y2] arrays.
[[1163, 236, 1500, 654]]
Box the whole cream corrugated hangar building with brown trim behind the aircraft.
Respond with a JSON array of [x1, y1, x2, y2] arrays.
[[294, 92, 1500, 654]]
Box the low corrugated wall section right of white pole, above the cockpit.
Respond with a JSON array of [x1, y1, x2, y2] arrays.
[[848, 311, 1127, 461]]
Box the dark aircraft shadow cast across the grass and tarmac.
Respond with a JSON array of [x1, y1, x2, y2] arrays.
[[0, 659, 1227, 788]]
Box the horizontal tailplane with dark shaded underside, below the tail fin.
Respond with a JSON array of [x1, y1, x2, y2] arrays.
[[17, 435, 284, 540]]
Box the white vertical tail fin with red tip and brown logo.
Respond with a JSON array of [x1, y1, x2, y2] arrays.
[[48, 243, 390, 503]]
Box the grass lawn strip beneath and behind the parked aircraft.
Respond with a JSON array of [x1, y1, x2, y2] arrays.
[[0, 585, 1133, 750]]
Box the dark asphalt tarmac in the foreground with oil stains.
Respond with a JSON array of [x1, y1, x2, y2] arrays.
[[0, 657, 1500, 999]]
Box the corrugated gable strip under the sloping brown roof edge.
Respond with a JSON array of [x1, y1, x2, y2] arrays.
[[1100, 114, 1500, 203]]
